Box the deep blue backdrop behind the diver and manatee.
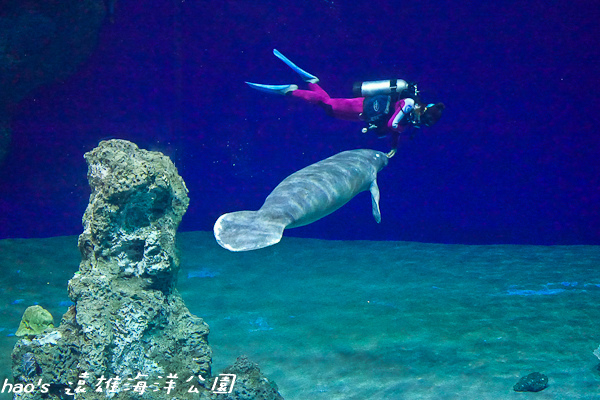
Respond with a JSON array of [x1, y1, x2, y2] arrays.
[[0, 0, 600, 244]]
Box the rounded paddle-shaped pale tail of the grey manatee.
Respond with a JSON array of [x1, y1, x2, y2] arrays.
[[214, 211, 285, 251]]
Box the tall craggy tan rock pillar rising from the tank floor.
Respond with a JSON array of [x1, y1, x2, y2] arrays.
[[12, 140, 281, 400]]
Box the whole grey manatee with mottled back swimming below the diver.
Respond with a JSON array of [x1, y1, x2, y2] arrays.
[[214, 149, 388, 251]]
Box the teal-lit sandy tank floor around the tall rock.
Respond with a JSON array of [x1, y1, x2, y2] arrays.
[[0, 232, 600, 400]]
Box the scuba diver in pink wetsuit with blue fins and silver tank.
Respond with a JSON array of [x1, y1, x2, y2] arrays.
[[246, 49, 445, 158]]
